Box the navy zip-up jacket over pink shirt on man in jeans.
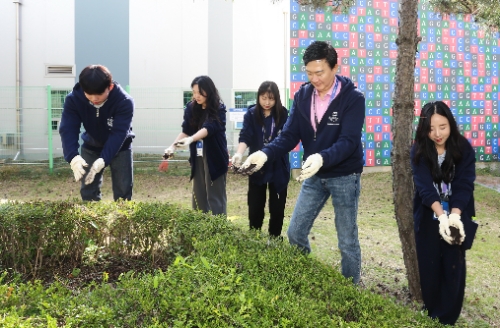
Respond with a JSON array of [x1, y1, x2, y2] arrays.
[[262, 75, 365, 179]]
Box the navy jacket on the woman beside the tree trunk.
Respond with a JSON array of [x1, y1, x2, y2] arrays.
[[410, 138, 476, 249]]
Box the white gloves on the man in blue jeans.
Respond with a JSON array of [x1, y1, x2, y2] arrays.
[[231, 150, 323, 182]]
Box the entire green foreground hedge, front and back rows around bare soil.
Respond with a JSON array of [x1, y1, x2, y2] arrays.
[[0, 202, 441, 328]]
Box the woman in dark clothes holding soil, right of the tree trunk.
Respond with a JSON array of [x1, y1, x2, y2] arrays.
[[411, 101, 477, 325]]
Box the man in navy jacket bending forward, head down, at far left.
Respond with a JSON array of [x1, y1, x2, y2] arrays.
[[59, 65, 135, 201]]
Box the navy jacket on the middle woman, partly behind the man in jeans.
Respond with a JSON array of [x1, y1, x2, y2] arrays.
[[239, 105, 290, 193]]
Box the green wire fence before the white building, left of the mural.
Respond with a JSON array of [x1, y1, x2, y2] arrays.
[[0, 86, 292, 170]]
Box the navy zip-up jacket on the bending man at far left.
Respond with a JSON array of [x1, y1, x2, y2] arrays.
[[59, 82, 135, 166]]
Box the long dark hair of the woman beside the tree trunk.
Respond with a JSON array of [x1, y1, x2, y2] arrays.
[[413, 101, 468, 183]]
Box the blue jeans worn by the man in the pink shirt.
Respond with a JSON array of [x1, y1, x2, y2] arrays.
[[287, 173, 361, 284]]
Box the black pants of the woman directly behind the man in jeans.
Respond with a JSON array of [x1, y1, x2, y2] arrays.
[[248, 181, 287, 237]]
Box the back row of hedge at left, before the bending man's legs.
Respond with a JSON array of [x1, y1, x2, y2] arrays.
[[0, 202, 208, 277]]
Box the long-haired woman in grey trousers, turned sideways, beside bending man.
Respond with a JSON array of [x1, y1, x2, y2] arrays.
[[164, 75, 229, 215]]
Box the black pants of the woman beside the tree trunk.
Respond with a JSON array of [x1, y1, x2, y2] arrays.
[[415, 217, 466, 325]]
